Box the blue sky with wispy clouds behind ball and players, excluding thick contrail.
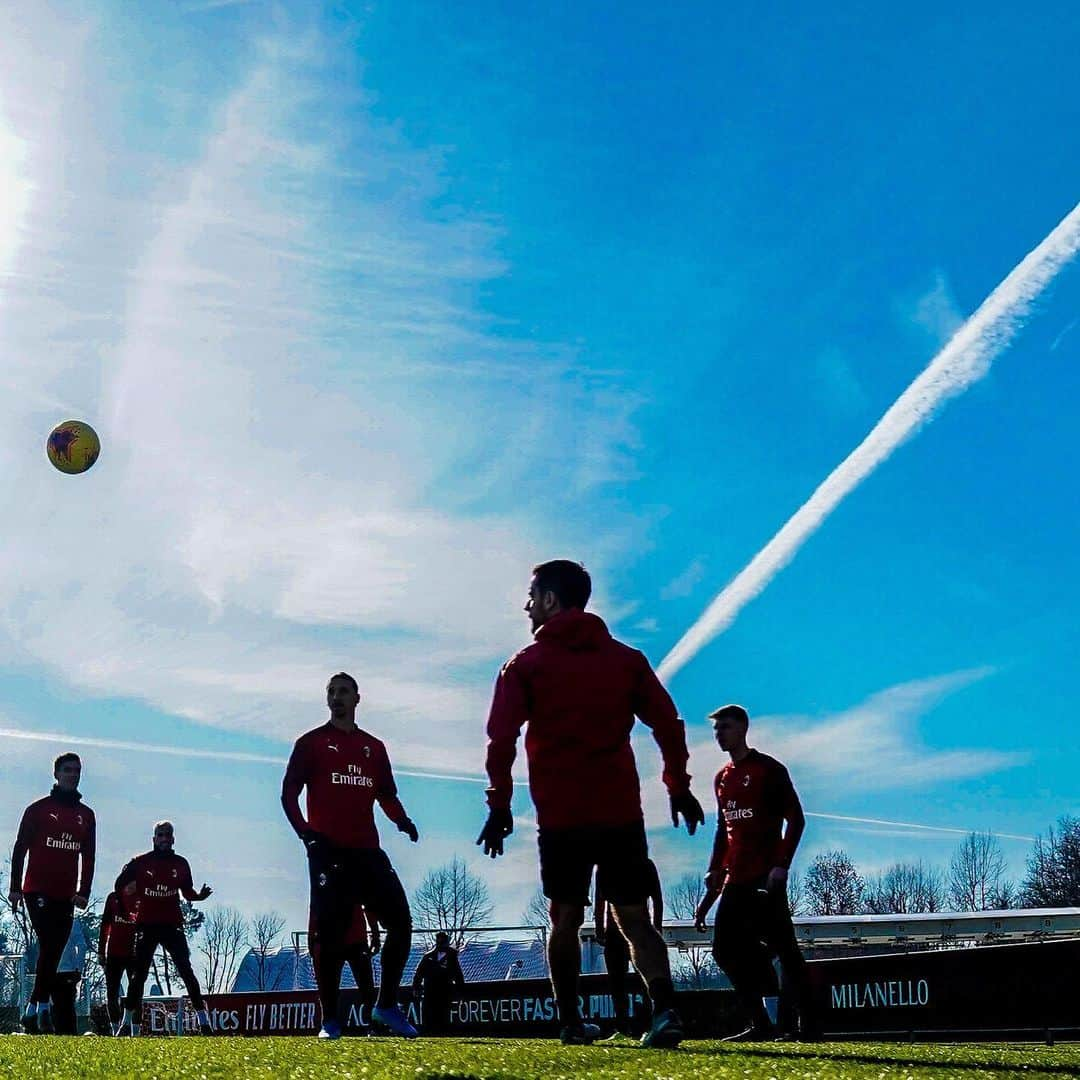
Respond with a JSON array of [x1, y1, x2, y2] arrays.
[[0, 0, 1080, 924]]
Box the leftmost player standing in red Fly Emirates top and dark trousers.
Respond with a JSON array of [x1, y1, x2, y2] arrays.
[[8, 753, 97, 1034]]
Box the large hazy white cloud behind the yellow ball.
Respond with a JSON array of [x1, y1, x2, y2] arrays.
[[0, 8, 636, 772]]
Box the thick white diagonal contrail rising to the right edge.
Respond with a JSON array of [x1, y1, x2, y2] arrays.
[[658, 198, 1080, 679]]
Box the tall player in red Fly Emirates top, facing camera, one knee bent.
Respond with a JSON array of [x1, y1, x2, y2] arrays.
[[281, 672, 420, 1039]]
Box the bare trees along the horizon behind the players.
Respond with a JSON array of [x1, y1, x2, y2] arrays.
[[0, 816, 1080, 1005]]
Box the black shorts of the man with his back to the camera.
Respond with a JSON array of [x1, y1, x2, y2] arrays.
[[539, 821, 652, 906]]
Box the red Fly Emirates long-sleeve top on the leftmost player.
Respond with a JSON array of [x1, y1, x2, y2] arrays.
[[11, 787, 97, 900]]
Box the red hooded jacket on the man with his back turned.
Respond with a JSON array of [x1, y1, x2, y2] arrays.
[[487, 610, 690, 828]]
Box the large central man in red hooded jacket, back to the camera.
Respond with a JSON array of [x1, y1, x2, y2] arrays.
[[476, 559, 705, 1047]]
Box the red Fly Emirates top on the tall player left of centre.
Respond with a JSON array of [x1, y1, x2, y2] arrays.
[[281, 723, 408, 849]]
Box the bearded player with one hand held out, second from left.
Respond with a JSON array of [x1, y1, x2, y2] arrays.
[[113, 821, 214, 1035]]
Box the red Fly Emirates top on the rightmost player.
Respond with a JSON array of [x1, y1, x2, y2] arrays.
[[708, 750, 806, 886]]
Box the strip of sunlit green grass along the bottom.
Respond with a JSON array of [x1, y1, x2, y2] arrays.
[[0, 1036, 1080, 1080]]
